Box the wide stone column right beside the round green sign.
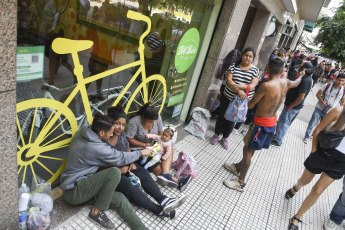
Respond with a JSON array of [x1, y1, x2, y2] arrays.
[[187, 0, 251, 117]]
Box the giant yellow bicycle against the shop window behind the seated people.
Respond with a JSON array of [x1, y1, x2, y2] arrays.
[[16, 11, 167, 183]]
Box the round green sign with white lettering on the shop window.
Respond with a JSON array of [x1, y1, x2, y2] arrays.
[[175, 28, 200, 73]]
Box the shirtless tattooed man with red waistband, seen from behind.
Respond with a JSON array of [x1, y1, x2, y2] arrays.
[[224, 58, 304, 192]]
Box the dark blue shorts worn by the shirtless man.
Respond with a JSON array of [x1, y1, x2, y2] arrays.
[[243, 123, 276, 150]]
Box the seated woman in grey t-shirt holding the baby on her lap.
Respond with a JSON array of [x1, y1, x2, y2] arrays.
[[126, 103, 192, 191]]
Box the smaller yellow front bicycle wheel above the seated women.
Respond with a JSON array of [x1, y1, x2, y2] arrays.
[[125, 74, 167, 114]]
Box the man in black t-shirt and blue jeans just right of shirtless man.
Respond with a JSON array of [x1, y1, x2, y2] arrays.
[[271, 62, 313, 147]]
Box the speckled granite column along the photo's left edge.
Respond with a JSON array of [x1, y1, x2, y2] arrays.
[[0, 0, 19, 229]]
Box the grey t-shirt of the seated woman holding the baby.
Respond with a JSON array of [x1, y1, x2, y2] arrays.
[[126, 115, 163, 151]]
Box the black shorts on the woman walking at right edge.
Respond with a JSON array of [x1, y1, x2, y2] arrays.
[[304, 149, 345, 180]]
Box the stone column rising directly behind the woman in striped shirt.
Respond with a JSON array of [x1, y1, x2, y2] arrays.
[[244, 9, 271, 65]]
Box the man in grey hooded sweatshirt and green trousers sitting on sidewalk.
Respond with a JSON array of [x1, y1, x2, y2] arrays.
[[60, 114, 151, 229]]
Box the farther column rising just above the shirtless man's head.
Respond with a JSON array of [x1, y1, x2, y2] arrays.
[[257, 23, 282, 70]]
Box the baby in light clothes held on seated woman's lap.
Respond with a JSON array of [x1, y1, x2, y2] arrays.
[[140, 128, 174, 169]]
